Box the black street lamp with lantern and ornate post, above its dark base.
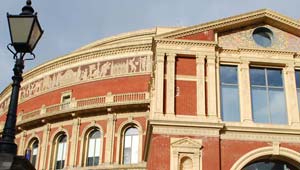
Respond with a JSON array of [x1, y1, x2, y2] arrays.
[[0, 0, 43, 168]]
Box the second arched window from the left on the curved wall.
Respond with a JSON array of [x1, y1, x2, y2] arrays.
[[55, 134, 67, 169]]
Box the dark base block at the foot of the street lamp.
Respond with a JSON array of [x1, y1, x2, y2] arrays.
[[0, 153, 35, 170]]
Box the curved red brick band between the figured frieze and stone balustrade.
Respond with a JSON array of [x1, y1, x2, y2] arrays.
[[15, 75, 150, 115]]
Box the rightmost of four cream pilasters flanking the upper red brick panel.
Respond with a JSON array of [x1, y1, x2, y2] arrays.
[[206, 55, 218, 119]]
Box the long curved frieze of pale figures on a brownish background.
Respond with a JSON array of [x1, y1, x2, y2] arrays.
[[0, 56, 151, 105]]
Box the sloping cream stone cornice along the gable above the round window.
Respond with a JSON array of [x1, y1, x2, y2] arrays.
[[157, 9, 300, 38]]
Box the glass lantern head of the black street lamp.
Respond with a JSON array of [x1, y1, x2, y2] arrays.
[[7, 14, 43, 53]]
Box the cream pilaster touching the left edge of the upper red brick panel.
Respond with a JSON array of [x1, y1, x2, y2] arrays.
[[166, 53, 176, 116]]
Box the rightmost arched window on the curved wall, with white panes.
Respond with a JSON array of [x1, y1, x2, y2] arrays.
[[123, 127, 139, 164]]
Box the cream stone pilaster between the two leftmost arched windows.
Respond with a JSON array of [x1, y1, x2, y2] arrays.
[[38, 124, 51, 170]]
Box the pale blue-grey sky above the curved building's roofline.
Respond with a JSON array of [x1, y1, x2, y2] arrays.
[[0, 0, 300, 91]]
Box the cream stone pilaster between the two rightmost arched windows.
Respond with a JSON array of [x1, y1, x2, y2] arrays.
[[104, 114, 116, 164]]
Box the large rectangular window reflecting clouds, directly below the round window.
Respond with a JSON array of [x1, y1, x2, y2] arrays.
[[250, 68, 287, 124]]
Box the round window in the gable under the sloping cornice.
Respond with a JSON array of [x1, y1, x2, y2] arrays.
[[252, 27, 273, 47]]
